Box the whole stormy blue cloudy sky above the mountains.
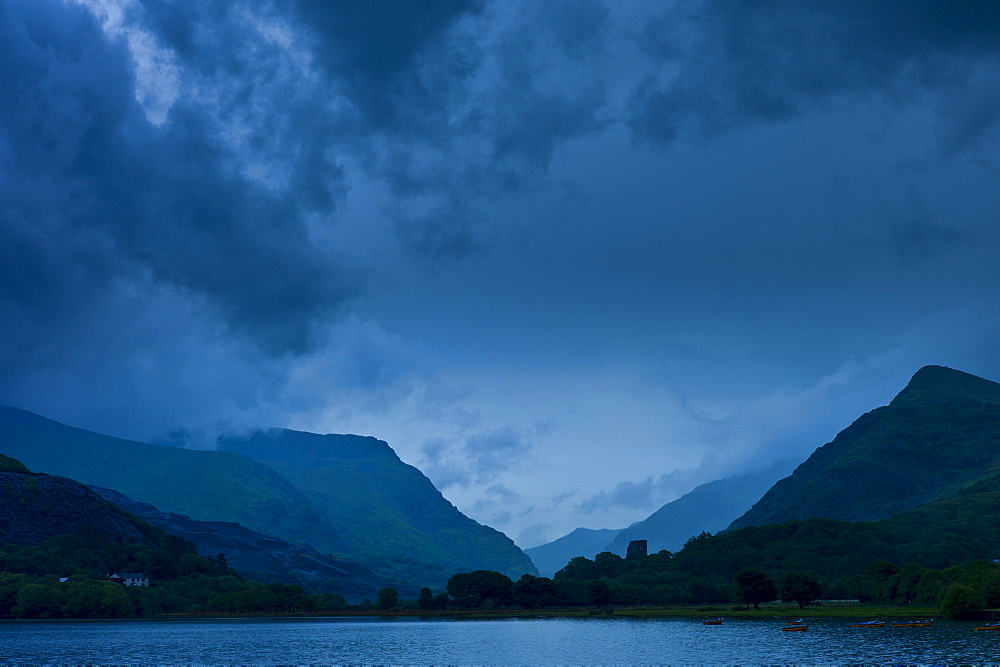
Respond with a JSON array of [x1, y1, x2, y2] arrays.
[[0, 0, 1000, 547]]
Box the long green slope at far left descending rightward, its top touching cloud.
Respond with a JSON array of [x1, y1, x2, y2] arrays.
[[0, 406, 346, 552]]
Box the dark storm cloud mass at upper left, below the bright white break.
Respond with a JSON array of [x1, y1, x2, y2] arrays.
[[0, 3, 357, 353]]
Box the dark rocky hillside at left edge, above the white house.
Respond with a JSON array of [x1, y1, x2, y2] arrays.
[[0, 457, 147, 546]]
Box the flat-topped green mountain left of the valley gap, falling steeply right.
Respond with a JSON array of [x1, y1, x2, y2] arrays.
[[219, 429, 536, 584]]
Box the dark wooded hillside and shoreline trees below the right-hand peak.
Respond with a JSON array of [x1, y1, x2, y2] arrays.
[[417, 509, 1000, 615]]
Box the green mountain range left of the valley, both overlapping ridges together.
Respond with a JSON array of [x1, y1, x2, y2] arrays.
[[0, 406, 537, 587]]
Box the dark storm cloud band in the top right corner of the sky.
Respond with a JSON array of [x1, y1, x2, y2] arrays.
[[629, 0, 1000, 149]]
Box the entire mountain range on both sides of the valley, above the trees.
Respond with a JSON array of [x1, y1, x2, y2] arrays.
[[0, 366, 1000, 592]]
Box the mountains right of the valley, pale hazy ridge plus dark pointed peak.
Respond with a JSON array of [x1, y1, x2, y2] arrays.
[[525, 366, 1000, 574]]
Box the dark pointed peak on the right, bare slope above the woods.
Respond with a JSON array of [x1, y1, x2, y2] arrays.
[[730, 366, 1000, 530]]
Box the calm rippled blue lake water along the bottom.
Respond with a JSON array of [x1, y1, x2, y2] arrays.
[[0, 617, 1000, 665]]
